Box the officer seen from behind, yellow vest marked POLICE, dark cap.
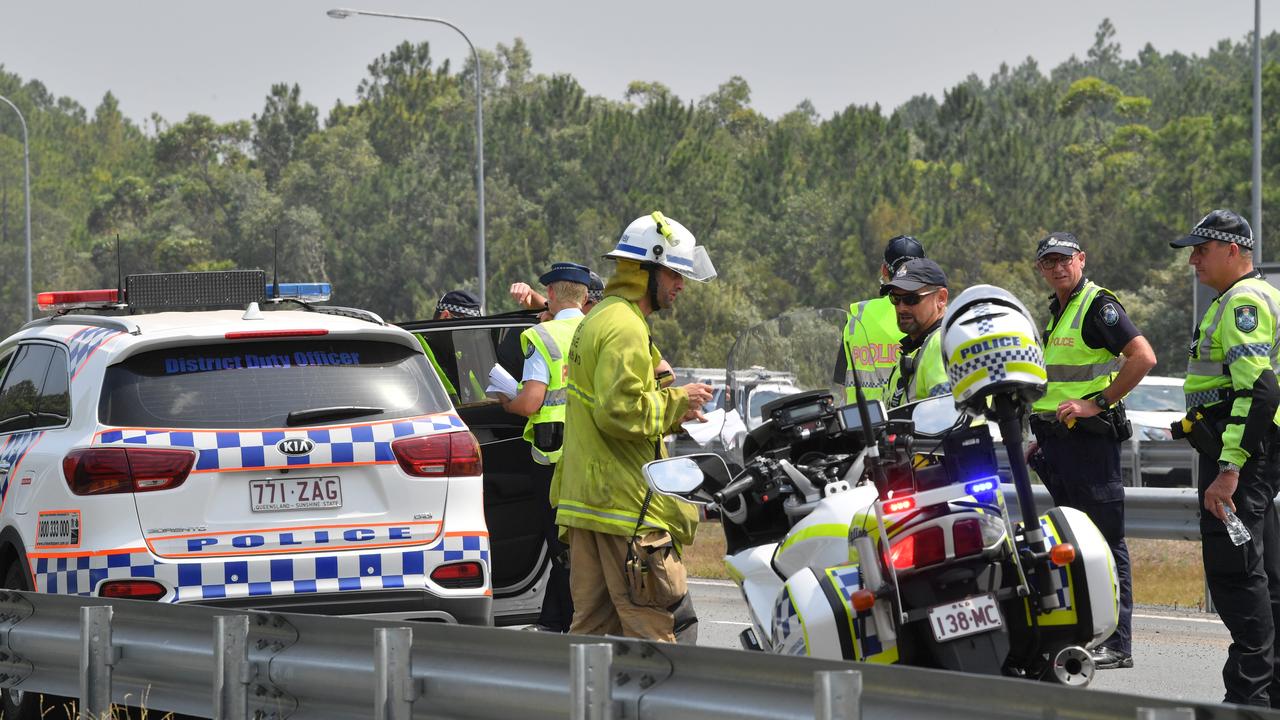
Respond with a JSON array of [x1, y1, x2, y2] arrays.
[[837, 234, 924, 402]]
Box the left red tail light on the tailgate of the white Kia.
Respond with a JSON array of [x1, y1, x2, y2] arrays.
[[63, 447, 196, 495]]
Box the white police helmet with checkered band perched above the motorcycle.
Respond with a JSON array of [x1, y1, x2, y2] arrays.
[[942, 284, 1047, 411]]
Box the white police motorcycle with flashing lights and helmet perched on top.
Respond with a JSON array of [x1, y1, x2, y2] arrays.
[[645, 286, 1117, 685]]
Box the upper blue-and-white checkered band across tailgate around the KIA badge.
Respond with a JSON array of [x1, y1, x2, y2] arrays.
[[97, 415, 466, 473]]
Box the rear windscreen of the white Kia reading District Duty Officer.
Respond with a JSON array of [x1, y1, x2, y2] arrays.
[[99, 340, 452, 428]]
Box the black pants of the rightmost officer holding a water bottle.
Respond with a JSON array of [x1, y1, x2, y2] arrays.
[[1198, 441, 1280, 707]]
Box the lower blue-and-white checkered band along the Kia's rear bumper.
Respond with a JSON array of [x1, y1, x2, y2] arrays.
[[33, 534, 489, 602]]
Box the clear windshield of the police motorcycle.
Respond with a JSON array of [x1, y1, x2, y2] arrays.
[[721, 307, 849, 464]]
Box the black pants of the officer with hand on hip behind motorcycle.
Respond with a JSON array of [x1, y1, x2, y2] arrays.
[[1036, 425, 1133, 655]]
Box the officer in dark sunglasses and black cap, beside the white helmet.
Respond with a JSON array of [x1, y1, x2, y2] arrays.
[[881, 258, 951, 407]]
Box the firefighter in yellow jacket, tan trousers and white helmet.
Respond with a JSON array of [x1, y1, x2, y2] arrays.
[[553, 213, 716, 642]]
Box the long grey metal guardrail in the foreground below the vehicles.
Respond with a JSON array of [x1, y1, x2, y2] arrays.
[[0, 591, 1264, 720]]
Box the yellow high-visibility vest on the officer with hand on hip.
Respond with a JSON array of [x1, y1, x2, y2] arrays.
[[1032, 282, 1120, 413]]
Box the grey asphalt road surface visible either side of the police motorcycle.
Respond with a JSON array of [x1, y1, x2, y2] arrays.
[[689, 579, 1231, 702]]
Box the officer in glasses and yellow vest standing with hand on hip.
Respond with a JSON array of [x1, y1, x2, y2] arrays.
[[1029, 232, 1156, 670]]
